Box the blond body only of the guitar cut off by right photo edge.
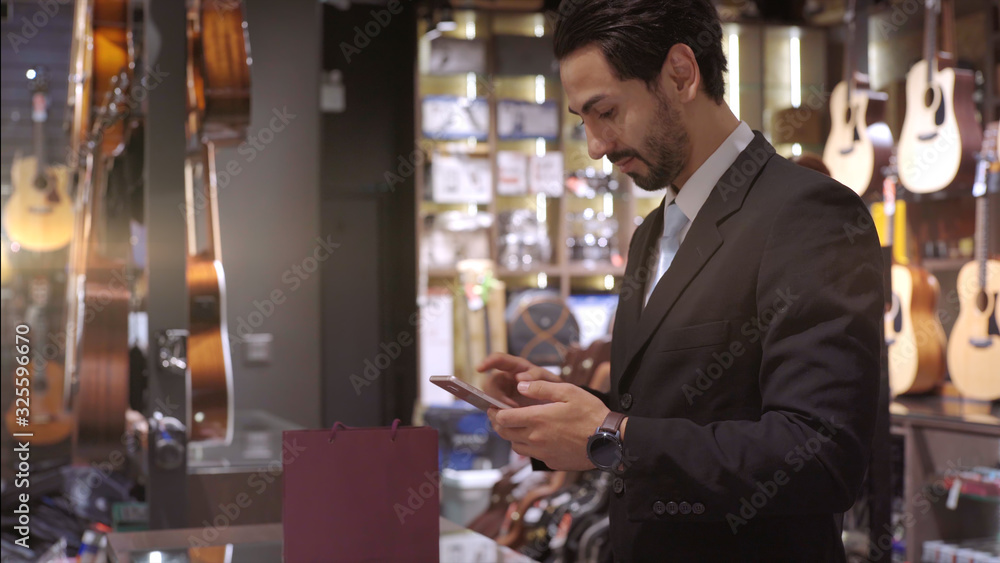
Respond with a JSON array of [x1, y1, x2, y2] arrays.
[[948, 260, 1000, 401]]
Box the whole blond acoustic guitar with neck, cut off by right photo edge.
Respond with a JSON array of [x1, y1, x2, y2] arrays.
[[948, 121, 1000, 401]]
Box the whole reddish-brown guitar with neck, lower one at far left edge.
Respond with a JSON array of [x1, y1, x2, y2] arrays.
[[4, 278, 73, 445]]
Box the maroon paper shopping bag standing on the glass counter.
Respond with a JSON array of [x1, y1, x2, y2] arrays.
[[282, 420, 440, 563]]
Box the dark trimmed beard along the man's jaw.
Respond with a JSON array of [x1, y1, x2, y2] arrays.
[[608, 93, 690, 192]]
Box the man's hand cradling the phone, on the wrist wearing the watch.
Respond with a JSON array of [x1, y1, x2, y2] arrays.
[[488, 381, 610, 470]]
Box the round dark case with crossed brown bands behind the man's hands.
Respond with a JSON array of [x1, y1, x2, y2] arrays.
[[507, 289, 580, 366]]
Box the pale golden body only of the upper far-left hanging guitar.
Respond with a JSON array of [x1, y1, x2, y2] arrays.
[[3, 156, 73, 252]]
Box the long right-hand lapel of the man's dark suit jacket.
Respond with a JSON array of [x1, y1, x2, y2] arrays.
[[614, 133, 774, 392]]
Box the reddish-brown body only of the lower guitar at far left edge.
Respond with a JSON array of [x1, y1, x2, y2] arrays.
[[4, 361, 73, 446]]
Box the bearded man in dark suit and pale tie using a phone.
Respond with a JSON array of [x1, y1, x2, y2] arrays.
[[480, 0, 883, 562]]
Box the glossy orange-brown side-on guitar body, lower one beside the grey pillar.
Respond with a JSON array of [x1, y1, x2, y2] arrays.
[[187, 254, 233, 443]]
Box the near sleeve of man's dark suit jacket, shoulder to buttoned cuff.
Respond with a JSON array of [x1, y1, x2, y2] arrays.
[[623, 180, 884, 531]]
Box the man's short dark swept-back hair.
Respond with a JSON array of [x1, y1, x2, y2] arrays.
[[555, 0, 726, 103]]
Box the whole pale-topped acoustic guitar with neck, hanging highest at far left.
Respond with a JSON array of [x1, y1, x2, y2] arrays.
[[3, 68, 73, 252]]
